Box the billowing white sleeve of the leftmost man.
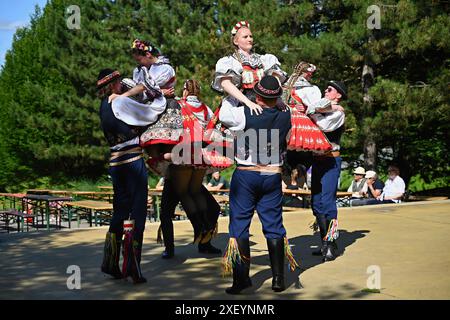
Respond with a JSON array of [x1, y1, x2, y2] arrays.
[[111, 96, 166, 126]]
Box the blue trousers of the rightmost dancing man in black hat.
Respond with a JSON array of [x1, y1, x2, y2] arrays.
[[311, 157, 342, 220]]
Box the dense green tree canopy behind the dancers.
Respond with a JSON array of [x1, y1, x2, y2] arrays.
[[0, 0, 450, 190]]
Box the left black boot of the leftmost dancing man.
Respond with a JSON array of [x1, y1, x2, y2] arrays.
[[101, 232, 123, 279]]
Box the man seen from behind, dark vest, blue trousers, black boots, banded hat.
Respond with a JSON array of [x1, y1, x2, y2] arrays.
[[219, 75, 297, 294]]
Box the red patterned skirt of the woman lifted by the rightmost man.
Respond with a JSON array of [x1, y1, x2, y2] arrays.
[[288, 107, 331, 151]]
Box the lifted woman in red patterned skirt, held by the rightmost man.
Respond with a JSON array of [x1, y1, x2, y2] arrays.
[[284, 61, 331, 151]]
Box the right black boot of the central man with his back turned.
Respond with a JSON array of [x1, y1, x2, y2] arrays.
[[267, 238, 286, 292]]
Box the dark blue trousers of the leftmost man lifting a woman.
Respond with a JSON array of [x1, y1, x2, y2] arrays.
[[109, 156, 148, 239]]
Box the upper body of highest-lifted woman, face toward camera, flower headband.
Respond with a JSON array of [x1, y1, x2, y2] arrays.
[[212, 21, 286, 114]]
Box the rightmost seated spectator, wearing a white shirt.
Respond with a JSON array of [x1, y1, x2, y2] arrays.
[[367, 165, 405, 204]]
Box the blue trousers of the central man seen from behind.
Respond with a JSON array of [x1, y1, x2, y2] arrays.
[[229, 169, 286, 239]]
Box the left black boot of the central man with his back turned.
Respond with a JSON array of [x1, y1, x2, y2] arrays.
[[225, 239, 252, 294]]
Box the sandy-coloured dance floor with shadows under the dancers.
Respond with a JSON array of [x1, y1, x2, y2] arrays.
[[0, 201, 450, 299]]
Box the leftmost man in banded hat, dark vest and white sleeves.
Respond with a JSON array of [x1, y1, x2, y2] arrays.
[[97, 69, 161, 283]]
